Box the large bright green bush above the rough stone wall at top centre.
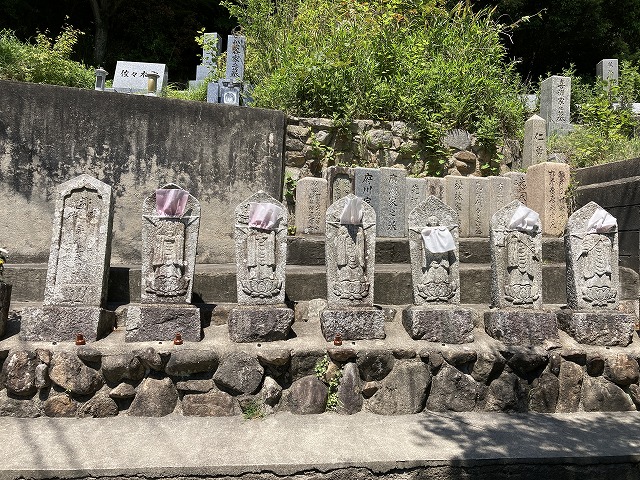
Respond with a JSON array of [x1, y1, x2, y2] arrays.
[[223, 0, 523, 169]]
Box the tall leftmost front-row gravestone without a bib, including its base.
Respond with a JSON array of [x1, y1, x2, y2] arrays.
[[20, 175, 115, 341]]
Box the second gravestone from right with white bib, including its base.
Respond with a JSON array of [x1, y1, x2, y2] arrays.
[[484, 200, 558, 345]]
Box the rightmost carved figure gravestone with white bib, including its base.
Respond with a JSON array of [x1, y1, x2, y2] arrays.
[[558, 202, 635, 346]]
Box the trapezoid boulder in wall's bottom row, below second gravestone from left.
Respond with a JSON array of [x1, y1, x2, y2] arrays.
[[129, 378, 178, 417]]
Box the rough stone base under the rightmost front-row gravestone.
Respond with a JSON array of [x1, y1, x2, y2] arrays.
[[558, 310, 636, 347]]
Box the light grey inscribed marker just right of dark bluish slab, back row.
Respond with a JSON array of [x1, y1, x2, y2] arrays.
[[376, 167, 407, 238]]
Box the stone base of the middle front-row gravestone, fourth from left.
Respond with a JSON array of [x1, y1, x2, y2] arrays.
[[320, 307, 386, 342]]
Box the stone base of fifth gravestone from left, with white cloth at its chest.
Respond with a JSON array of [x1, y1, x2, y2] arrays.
[[402, 305, 473, 343]]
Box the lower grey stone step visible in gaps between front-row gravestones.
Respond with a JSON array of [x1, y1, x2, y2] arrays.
[[5, 263, 638, 305]]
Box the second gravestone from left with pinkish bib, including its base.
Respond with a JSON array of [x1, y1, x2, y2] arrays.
[[125, 183, 201, 342]]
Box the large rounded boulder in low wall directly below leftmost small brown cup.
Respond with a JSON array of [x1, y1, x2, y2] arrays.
[[49, 352, 104, 395]]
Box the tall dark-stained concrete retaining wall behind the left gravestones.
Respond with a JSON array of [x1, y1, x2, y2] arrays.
[[0, 81, 285, 265]]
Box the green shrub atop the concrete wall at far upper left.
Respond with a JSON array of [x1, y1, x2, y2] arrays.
[[0, 25, 95, 88]]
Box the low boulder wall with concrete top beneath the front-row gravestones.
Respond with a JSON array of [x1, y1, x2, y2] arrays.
[[5, 301, 640, 417]]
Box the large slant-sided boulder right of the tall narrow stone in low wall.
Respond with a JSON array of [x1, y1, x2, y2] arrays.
[[365, 360, 432, 415]]
